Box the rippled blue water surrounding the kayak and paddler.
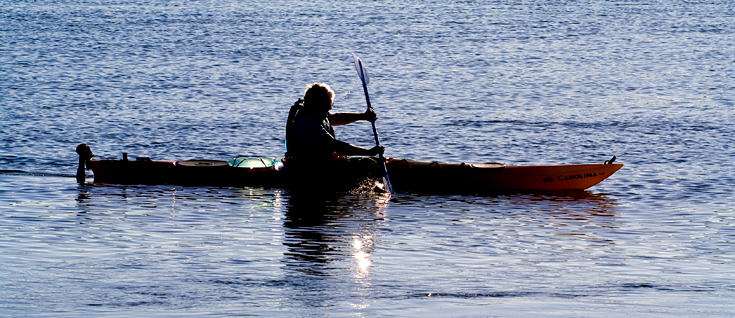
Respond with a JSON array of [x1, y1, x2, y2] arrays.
[[0, 0, 735, 317]]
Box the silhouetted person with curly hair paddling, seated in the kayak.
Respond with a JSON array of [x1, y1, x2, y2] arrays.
[[286, 83, 385, 167]]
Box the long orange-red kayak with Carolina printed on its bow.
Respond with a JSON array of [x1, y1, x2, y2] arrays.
[[77, 145, 623, 194]]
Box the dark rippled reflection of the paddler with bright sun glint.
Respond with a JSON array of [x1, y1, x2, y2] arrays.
[[283, 193, 390, 277]]
